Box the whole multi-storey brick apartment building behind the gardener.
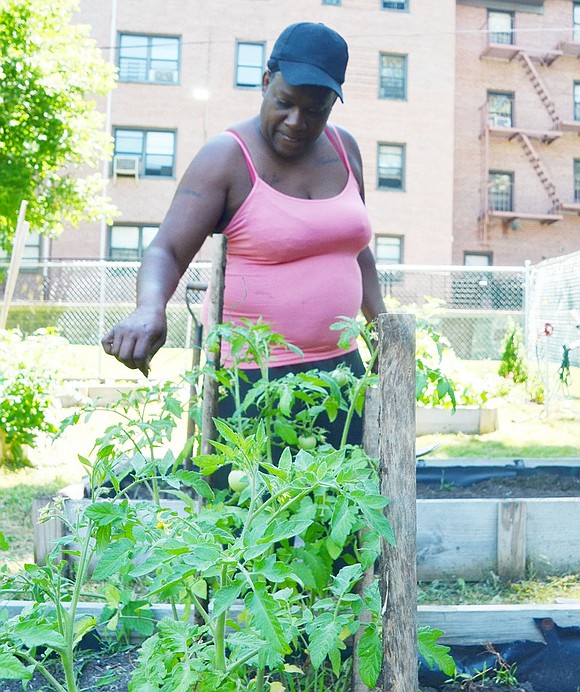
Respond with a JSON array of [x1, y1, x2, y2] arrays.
[[45, 0, 580, 265]]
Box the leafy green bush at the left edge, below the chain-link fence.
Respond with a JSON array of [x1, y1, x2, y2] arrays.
[[0, 330, 63, 469]]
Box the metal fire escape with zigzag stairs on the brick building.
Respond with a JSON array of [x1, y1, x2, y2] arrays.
[[480, 25, 580, 241]]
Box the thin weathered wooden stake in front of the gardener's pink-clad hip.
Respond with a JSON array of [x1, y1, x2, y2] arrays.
[[201, 233, 227, 454]]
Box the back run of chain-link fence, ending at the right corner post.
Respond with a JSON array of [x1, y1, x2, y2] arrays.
[[0, 260, 532, 370]]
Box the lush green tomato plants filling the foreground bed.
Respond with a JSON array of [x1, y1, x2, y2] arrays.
[[0, 325, 448, 692]]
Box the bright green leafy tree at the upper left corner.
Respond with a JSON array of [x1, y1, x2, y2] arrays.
[[0, 0, 115, 250]]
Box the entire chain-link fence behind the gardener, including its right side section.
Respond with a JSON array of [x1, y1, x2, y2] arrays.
[[7, 253, 580, 365]]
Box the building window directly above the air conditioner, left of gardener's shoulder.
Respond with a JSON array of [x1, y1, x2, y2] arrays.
[[115, 129, 175, 178]]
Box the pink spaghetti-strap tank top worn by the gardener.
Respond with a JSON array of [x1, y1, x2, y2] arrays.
[[206, 128, 372, 367]]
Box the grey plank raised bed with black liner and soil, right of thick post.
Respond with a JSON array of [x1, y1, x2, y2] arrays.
[[417, 459, 580, 581]]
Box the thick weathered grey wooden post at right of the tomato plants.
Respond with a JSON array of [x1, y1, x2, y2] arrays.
[[378, 314, 418, 692]]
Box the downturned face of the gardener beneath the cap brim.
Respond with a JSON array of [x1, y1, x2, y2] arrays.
[[260, 72, 336, 159]]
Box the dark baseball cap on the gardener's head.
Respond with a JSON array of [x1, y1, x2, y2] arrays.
[[268, 22, 348, 101]]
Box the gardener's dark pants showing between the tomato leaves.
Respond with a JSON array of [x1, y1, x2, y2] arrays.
[[212, 351, 365, 489]]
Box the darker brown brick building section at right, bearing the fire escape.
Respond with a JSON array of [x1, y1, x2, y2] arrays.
[[453, 0, 580, 265]]
